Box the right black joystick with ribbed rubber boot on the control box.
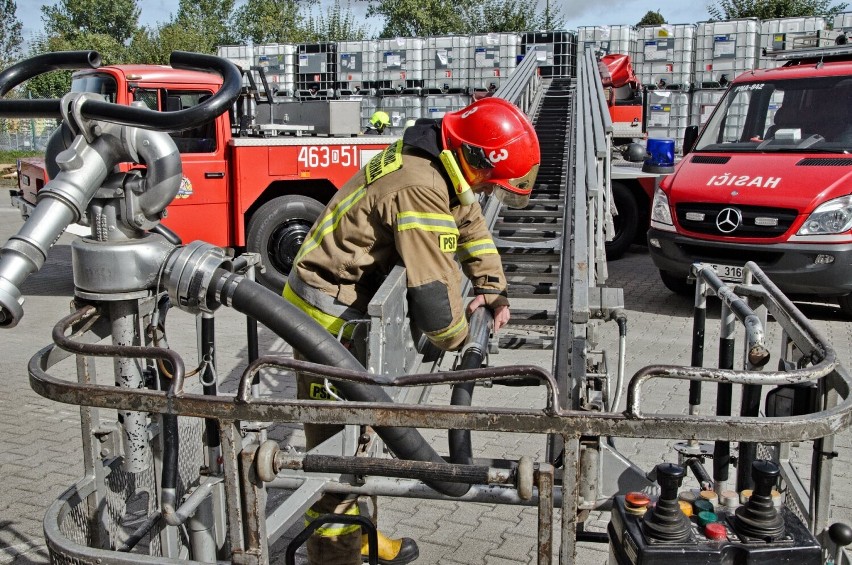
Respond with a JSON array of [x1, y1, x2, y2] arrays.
[[734, 460, 784, 541]]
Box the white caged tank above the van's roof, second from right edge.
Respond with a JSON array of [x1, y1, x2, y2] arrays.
[[760, 16, 838, 69]]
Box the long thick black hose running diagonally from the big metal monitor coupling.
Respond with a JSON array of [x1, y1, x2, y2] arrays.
[[211, 269, 470, 496]]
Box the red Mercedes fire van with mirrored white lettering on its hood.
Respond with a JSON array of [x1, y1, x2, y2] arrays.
[[648, 46, 852, 315]]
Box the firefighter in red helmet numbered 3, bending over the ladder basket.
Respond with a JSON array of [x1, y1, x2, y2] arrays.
[[283, 98, 540, 565]]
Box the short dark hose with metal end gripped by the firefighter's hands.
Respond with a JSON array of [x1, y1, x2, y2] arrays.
[[447, 306, 494, 465]]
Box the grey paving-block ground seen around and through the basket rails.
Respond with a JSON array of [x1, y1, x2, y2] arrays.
[[0, 207, 852, 565]]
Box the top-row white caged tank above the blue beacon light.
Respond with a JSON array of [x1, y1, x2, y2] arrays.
[[633, 24, 696, 90]]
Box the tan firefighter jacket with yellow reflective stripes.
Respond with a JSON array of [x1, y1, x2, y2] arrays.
[[284, 137, 508, 350]]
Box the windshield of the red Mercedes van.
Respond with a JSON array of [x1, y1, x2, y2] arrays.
[[695, 77, 852, 153]]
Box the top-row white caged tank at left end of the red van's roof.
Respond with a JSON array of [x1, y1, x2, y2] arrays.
[[695, 18, 760, 88]]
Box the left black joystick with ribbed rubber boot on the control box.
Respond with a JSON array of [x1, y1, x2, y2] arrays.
[[642, 463, 692, 543]]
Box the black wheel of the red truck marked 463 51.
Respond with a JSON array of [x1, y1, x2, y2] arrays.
[[246, 195, 325, 292]]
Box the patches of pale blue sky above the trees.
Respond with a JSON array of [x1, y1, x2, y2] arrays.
[[17, 0, 715, 41]]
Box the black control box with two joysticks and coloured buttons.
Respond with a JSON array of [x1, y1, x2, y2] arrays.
[[608, 461, 822, 565]]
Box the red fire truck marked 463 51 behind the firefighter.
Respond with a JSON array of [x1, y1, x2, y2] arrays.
[[12, 65, 393, 290]]
